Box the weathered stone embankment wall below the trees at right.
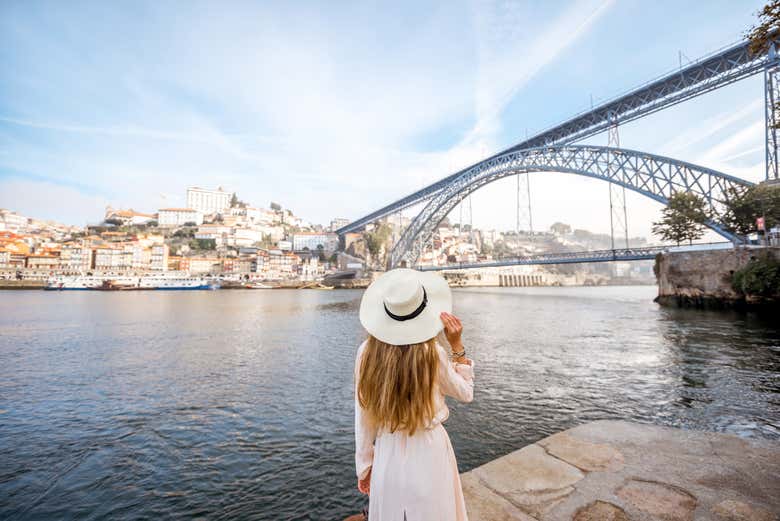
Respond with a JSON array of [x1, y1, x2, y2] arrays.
[[654, 247, 780, 307]]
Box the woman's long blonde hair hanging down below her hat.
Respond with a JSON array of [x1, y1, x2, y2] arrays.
[[357, 335, 439, 436]]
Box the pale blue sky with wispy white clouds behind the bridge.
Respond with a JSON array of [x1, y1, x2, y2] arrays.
[[0, 0, 763, 240]]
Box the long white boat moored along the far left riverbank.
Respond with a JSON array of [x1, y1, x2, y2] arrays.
[[44, 273, 220, 291]]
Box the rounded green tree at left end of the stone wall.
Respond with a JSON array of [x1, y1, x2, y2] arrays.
[[653, 192, 709, 245]]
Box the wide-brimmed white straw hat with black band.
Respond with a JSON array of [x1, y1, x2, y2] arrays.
[[360, 268, 452, 345]]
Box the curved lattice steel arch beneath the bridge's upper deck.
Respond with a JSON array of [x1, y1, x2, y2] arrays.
[[390, 145, 753, 268]]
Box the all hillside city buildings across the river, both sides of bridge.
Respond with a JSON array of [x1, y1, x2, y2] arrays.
[[0, 187, 652, 285]]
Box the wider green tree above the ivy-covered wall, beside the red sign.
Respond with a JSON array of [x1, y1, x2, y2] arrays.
[[722, 184, 780, 235]]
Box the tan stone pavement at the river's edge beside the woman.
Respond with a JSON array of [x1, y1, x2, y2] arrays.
[[461, 421, 780, 521]]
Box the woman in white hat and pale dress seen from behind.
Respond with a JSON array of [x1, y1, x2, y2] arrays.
[[355, 268, 474, 521]]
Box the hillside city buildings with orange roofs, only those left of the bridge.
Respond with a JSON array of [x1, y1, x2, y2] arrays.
[[0, 187, 345, 280]]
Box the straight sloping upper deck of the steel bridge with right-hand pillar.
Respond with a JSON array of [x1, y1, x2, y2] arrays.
[[337, 37, 780, 243]]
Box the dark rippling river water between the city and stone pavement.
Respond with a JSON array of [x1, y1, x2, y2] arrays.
[[0, 287, 780, 521]]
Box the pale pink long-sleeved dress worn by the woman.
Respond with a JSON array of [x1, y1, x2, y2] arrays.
[[355, 342, 474, 521]]
